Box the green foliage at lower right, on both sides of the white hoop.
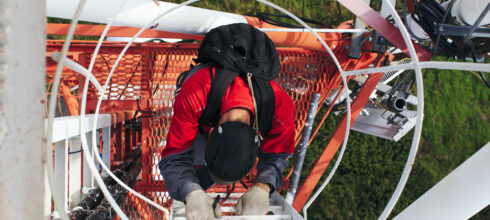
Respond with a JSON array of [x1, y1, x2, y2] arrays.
[[302, 58, 490, 219]]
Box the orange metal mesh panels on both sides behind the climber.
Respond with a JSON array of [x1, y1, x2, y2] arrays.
[[47, 40, 348, 219]]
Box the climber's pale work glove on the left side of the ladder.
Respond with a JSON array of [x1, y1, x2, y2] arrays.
[[185, 189, 221, 220]]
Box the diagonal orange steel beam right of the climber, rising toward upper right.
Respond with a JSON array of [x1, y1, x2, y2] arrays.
[[293, 73, 383, 212]]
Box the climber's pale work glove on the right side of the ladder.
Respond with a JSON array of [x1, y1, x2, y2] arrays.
[[236, 186, 269, 215]]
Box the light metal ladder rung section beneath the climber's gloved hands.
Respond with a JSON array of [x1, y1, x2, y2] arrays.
[[170, 192, 303, 220]]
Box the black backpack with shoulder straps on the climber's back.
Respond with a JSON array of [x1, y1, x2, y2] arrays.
[[177, 23, 281, 134]]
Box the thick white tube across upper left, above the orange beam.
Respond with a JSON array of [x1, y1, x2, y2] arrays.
[[46, 0, 247, 34]]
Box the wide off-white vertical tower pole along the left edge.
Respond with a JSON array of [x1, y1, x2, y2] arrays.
[[0, 0, 46, 219]]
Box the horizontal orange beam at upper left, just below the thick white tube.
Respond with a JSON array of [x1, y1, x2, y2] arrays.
[[46, 23, 204, 40]]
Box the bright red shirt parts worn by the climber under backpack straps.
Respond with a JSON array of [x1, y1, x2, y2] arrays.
[[162, 68, 295, 157]]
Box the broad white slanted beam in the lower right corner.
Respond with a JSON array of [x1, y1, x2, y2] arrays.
[[394, 143, 490, 220]]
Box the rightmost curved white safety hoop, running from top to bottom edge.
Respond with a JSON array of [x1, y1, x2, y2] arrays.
[[378, 0, 424, 220]]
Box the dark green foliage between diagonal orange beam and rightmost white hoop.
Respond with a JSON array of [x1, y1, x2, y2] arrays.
[[304, 117, 410, 219]]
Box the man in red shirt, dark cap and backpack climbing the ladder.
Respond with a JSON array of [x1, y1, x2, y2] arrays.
[[159, 24, 295, 220]]
